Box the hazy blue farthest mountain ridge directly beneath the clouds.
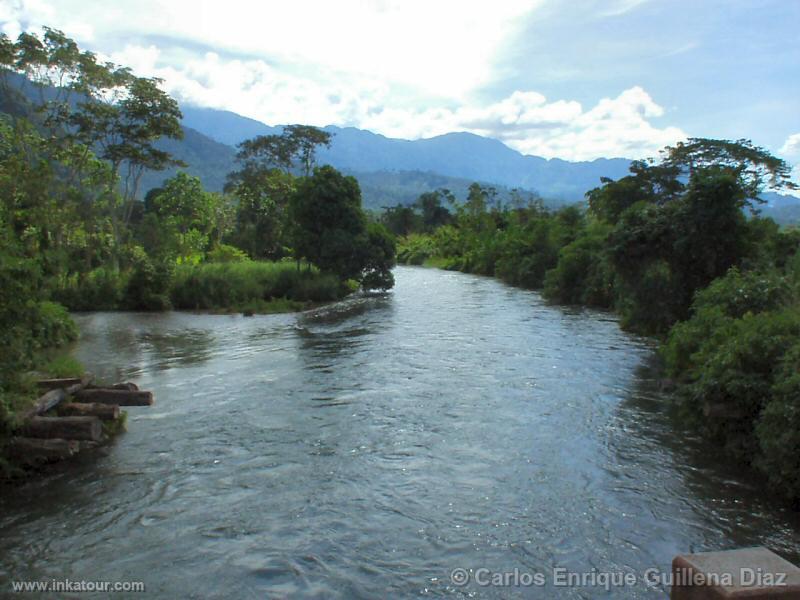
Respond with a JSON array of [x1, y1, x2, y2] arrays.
[[182, 106, 630, 202]]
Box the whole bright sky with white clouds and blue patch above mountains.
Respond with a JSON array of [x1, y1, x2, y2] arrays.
[[0, 0, 800, 183]]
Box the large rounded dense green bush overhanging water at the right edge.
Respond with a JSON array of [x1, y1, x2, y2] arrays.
[[662, 259, 800, 500]]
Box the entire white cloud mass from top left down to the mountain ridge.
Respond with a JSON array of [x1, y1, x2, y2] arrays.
[[0, 0, 686, 160]]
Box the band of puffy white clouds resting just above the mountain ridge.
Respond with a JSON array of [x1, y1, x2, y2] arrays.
[[106, 41, 687, 160]]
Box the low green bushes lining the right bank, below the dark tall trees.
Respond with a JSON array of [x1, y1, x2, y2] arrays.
[[398, 225, 800, 509]]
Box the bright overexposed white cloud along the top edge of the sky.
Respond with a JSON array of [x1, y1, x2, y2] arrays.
[[4, 0, 543, 97]]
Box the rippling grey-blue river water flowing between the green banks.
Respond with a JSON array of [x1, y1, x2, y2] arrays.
[[0, 267, 800, 599]]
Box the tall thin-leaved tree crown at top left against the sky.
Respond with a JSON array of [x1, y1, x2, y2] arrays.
[[0, 28, 183, 255]]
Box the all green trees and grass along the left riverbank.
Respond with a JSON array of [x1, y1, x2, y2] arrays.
[[0, 28, 395, 460]]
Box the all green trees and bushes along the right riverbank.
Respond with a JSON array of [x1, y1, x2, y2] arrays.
[[390, 139, 800, 501]]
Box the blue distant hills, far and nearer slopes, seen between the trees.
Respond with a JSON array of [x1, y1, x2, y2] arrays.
[[0, 76, 800, 225]]
